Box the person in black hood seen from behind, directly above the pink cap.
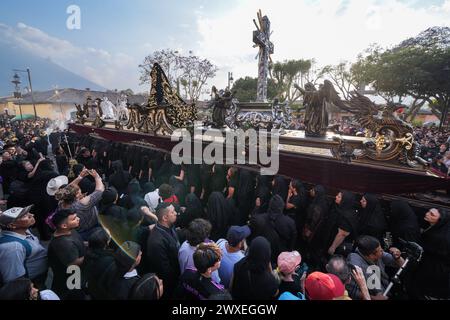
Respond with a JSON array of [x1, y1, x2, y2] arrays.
[[250, 195, 297, 264]]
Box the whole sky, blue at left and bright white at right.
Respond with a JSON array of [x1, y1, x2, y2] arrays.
[[0, 0, 450, 96]]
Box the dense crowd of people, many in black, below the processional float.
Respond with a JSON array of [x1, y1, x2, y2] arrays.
[[0, 121, 450, 300]]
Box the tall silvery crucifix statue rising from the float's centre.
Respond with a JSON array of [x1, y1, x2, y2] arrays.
[[253, 10, 273, 102]]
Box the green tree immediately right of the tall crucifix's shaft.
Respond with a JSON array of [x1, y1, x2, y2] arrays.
[[270, 60, 312, 104]]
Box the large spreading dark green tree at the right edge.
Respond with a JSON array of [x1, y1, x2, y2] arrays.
[[358, 27, 450, 128]]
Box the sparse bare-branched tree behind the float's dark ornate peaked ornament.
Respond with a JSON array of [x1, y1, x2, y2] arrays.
[[139, 49, 218, 101]]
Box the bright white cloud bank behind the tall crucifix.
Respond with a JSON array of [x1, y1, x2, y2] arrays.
[[196, 0, 450, 87]]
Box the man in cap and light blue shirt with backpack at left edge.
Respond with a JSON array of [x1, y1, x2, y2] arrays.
[[0, 205, 48, 288]]
